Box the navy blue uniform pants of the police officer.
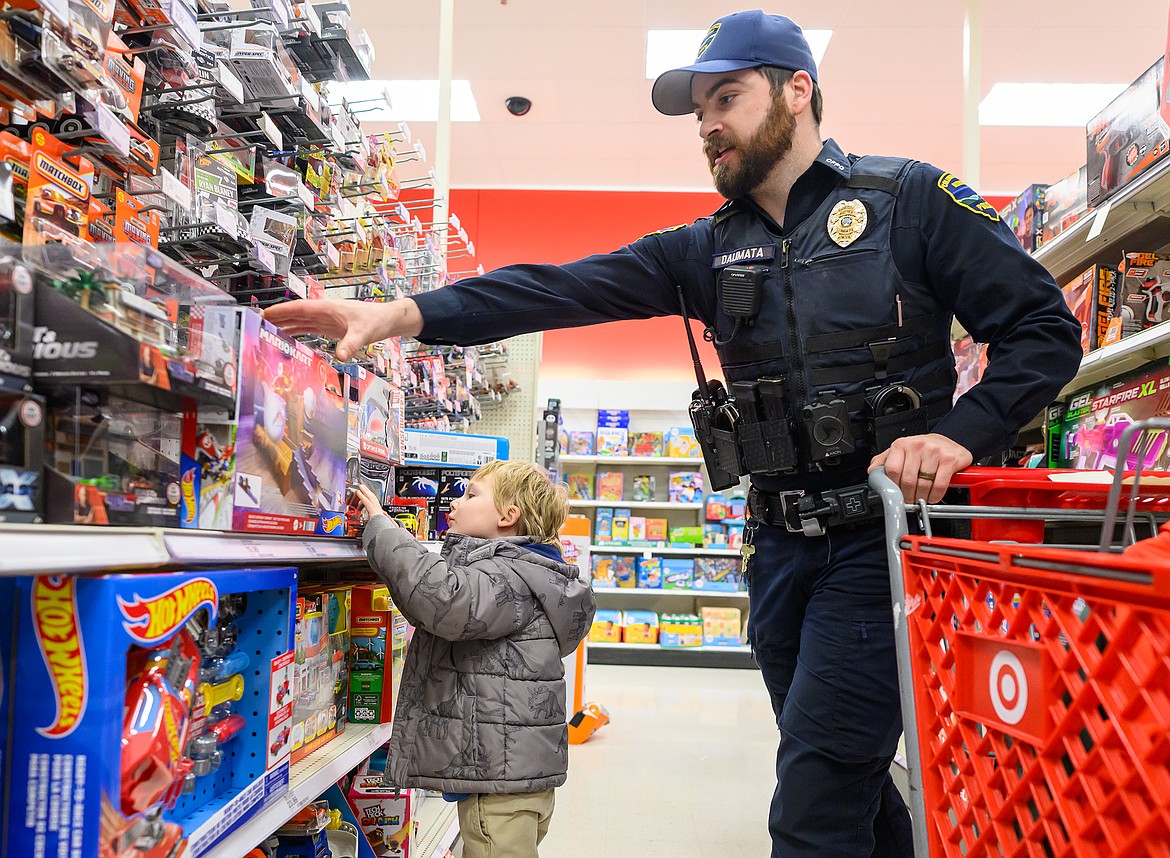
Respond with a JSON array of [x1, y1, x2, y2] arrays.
[[748, 522, 914, 858]]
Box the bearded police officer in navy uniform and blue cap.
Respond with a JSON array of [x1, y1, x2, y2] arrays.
[[266, 12, 1081, 858]]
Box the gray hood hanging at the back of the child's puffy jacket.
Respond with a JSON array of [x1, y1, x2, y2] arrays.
[[442, 534, 597, 657]]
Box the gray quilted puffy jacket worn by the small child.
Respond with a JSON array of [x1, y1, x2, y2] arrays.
[[363, 516, 597, 794]]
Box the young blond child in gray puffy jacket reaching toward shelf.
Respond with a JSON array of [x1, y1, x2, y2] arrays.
[[348, 461, 596, 858]]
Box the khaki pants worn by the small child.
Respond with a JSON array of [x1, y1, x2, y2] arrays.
[[459, 789, 553, 858]]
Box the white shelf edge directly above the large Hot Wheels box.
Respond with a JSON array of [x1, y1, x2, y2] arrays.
[[0, 524, 365, 576]]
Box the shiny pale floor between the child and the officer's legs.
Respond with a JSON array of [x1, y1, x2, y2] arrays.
[[541, 665, 778, 858]]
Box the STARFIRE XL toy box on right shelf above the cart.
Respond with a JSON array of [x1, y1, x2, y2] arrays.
[[1048, 363, 1170, 471]]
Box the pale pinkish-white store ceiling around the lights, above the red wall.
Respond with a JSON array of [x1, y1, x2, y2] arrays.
[[351, 0, 1168, 195]]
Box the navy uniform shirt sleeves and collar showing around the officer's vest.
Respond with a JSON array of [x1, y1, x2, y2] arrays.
[[414, 139, 1081, 460]]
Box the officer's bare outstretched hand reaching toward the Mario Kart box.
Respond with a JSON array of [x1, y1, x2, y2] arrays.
[[264, 298, 422, 361]]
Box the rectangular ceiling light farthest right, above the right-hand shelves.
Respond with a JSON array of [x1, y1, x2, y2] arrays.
[[979, 83, 1129, 128]]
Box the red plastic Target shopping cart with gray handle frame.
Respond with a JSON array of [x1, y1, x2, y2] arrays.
[[870, 420, 1170, 858]]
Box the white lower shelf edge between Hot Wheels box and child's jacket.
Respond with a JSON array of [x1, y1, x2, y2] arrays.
[[190, 723, 392, 858]]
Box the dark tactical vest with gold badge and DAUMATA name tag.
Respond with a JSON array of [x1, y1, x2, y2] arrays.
[[711, 156, 955, 490]]
